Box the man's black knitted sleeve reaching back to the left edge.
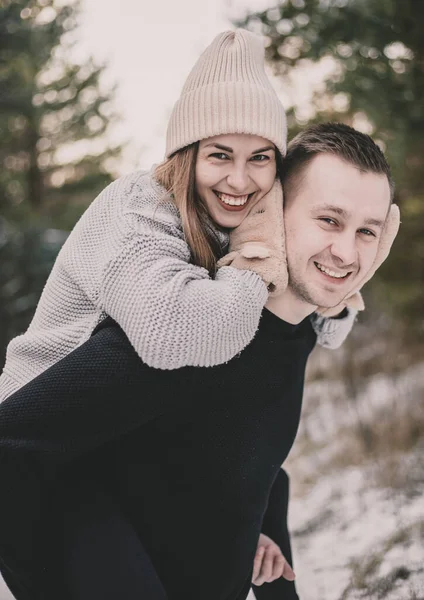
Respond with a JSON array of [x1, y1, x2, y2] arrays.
[[0, 320, 194, 466]]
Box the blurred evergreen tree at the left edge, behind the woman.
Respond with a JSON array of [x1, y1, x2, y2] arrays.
[[0, 0, 121, 370]]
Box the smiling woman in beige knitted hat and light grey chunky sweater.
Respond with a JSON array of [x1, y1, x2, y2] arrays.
[[0, 30, 352, 401]]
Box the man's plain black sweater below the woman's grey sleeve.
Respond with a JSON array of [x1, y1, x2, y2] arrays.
[[0, 310, 315, 600]]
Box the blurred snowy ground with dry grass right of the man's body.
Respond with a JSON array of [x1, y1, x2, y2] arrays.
[[249, 364, 424, 600]]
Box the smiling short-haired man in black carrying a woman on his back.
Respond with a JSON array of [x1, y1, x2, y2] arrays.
[[0, 124, 397, 600]]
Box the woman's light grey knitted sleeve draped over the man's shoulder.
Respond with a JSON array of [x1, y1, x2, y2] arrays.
[[99, 220, 268, 369]]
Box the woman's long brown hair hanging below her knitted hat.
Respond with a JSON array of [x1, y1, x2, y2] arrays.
[[155, 142, 283, 276]]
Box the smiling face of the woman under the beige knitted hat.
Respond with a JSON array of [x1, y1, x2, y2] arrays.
[[196, 133, 277, 228]]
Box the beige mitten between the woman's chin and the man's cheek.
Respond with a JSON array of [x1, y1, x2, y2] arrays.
[[218, 180, 288, 296]]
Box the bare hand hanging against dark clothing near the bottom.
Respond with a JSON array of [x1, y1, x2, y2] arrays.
[[252, 533, 296, 585]]
